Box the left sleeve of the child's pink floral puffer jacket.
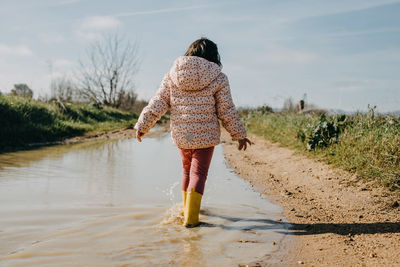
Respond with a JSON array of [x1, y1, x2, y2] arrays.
[[134, 73, 172, 134]]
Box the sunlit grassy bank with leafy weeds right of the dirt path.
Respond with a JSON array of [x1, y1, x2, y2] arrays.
[[243, 110, 400, 190]]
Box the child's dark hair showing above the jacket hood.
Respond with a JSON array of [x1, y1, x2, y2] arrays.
[[185, 37, 222, 66]]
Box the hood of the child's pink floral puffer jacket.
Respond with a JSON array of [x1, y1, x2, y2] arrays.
[[169, 56, 221, 91]]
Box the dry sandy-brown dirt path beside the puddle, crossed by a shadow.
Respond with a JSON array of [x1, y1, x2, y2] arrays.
[[222, 132, 400, 266]]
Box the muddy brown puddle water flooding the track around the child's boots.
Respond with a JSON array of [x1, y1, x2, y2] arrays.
[[0, 133, 288, 266]]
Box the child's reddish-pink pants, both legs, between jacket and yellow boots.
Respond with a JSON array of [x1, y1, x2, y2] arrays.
[[179, 146, 214, 194]]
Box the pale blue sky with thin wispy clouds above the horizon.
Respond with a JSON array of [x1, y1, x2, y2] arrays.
[[0, 0, 400, 112]]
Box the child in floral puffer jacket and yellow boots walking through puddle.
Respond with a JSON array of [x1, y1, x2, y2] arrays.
[[135, 38, 251, 227]]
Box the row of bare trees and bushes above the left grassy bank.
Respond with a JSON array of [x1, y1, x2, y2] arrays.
[[3, 34, 147, 112]]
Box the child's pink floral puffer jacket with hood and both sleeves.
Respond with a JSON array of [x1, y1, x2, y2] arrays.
[[135, 56, 246, 149]]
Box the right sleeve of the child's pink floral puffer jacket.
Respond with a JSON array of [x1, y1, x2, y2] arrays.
[[215, 74, 246, 141]]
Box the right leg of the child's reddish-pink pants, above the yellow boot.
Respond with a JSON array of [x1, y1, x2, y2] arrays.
[[186, 147, 214, 194]]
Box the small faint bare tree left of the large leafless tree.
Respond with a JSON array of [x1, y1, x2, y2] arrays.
[[50, 76, 77, 102]]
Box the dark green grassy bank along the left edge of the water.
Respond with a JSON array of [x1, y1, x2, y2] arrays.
[[0, 96, 137, 151]]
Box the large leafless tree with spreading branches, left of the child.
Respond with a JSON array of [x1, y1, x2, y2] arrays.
[[78, 35, 139, 106]]
